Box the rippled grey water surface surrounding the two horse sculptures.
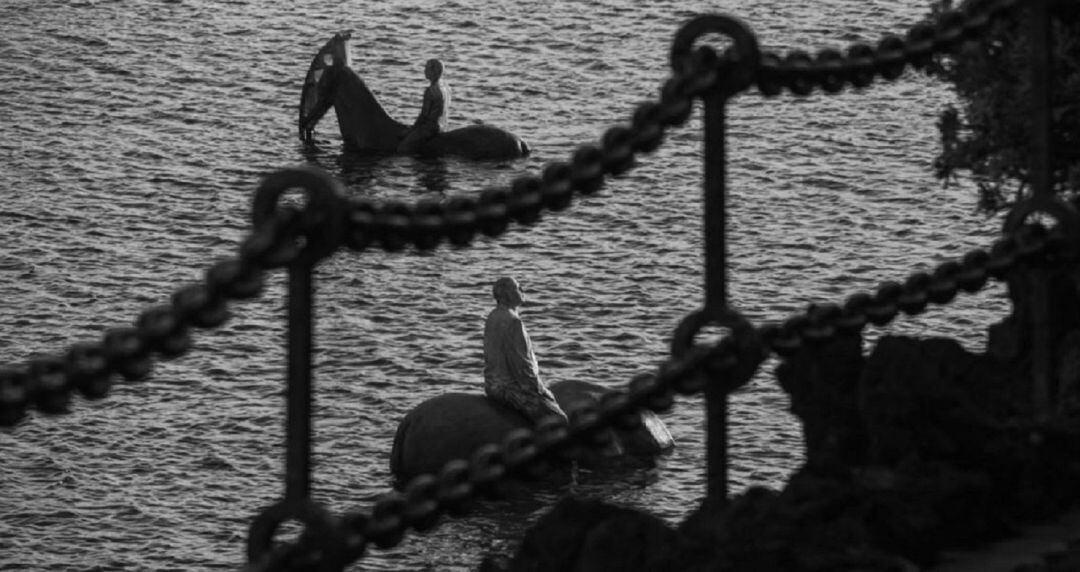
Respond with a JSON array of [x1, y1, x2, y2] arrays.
[[0, 0, 1005, 570]]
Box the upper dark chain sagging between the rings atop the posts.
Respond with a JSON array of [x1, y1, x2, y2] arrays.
[[0, 0, 1020, 426]]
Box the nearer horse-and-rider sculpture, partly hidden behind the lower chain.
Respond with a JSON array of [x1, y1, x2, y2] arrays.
[[390, 277, 674, 484]]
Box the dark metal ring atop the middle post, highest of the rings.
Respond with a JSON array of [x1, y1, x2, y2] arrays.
[[671, 14, 761, 94]]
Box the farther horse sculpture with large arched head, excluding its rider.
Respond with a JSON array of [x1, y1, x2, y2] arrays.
[[299, 32, 529, 161]]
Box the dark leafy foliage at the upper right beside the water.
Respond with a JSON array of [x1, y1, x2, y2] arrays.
[[928, 0, 1080, 214]]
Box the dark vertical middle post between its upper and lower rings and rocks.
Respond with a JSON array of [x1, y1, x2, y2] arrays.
[[704, 88, 728, 499]]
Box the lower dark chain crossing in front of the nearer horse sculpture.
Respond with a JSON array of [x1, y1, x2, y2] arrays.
[[247, 221, 1077, 572]]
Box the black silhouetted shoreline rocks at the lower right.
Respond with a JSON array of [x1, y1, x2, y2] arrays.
[[482, 268, 1080, 572]]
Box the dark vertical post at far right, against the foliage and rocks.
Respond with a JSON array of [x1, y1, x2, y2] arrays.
[[1028, 0, 1064, 421]]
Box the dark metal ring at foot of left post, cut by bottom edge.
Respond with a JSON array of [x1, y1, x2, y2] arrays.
[[247, 499, 345, 571]]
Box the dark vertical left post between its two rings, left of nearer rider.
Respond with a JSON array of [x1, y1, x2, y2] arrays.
[[285, 255, 314, 500]]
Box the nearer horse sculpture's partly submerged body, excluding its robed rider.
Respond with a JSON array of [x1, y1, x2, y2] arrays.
[[390, 380, 675, 482]]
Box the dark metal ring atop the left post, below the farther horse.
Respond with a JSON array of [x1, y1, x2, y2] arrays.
[[252, 165, 348, 263]]
